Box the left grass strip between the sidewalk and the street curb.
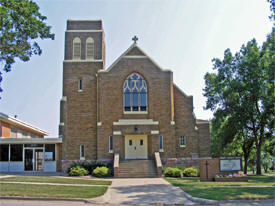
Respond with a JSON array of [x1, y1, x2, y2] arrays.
[[0, 183, 107, 198]]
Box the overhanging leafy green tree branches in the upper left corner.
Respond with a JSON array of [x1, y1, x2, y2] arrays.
[[0, 0, 54, 96]]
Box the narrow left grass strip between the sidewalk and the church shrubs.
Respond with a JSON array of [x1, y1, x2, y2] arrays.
[[0, 176, 112, 185]]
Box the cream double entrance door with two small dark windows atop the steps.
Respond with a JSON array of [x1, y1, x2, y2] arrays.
[[125, 135, 148, 159]]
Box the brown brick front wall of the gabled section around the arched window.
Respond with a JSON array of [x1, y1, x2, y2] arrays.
[[97, 53, 175, 159]]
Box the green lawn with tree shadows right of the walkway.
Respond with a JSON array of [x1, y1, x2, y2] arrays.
[[165, 175, 275, 200]]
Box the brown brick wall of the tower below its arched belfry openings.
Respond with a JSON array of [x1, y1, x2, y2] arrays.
[[61, 62, 102, 159]]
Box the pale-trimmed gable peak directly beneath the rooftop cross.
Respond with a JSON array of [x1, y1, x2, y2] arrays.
[[102, 43, 171, 72]]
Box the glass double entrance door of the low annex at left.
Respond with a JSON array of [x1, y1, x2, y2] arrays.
[[24, 148, 44, 171]]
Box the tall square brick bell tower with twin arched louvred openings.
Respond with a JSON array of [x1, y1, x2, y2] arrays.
[[59, 20, 105, 160]]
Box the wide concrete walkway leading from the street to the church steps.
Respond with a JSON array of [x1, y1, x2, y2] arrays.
[[90, 178, 198, 205]]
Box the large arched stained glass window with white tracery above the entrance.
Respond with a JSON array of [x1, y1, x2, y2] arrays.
[[123, 73, 147, 112]]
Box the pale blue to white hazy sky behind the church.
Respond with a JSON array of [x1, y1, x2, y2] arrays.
[[0, 0, 272, 137]]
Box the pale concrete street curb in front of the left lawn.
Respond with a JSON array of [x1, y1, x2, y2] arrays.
[[0, 196, 90, 203]]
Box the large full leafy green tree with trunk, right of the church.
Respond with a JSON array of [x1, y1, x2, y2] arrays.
[[204, 28, 275, 174]]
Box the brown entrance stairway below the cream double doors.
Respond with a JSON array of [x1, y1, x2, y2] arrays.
[[118, 160, 158, 178]]
